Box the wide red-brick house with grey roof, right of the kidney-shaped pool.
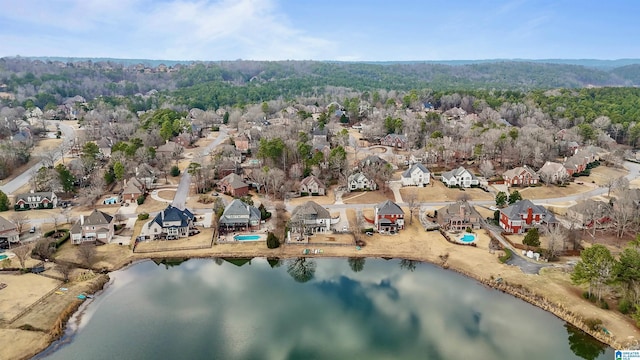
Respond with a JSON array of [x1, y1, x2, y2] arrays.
[[500, 200, 557, 234]]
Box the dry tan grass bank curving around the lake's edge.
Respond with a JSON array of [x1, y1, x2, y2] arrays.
[[7, 232, 640, 359]]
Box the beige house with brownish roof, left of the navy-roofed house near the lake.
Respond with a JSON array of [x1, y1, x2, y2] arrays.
[[69, 210, 115, 245]]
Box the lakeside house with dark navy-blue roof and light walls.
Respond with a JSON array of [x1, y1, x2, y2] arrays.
[[147, 205, 195, 240]]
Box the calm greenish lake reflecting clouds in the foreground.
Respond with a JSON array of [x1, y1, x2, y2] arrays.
[[37, 259, 613, 360]]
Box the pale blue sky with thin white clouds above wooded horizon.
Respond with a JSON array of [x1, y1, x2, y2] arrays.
[[0, 0, 640, 61]]
